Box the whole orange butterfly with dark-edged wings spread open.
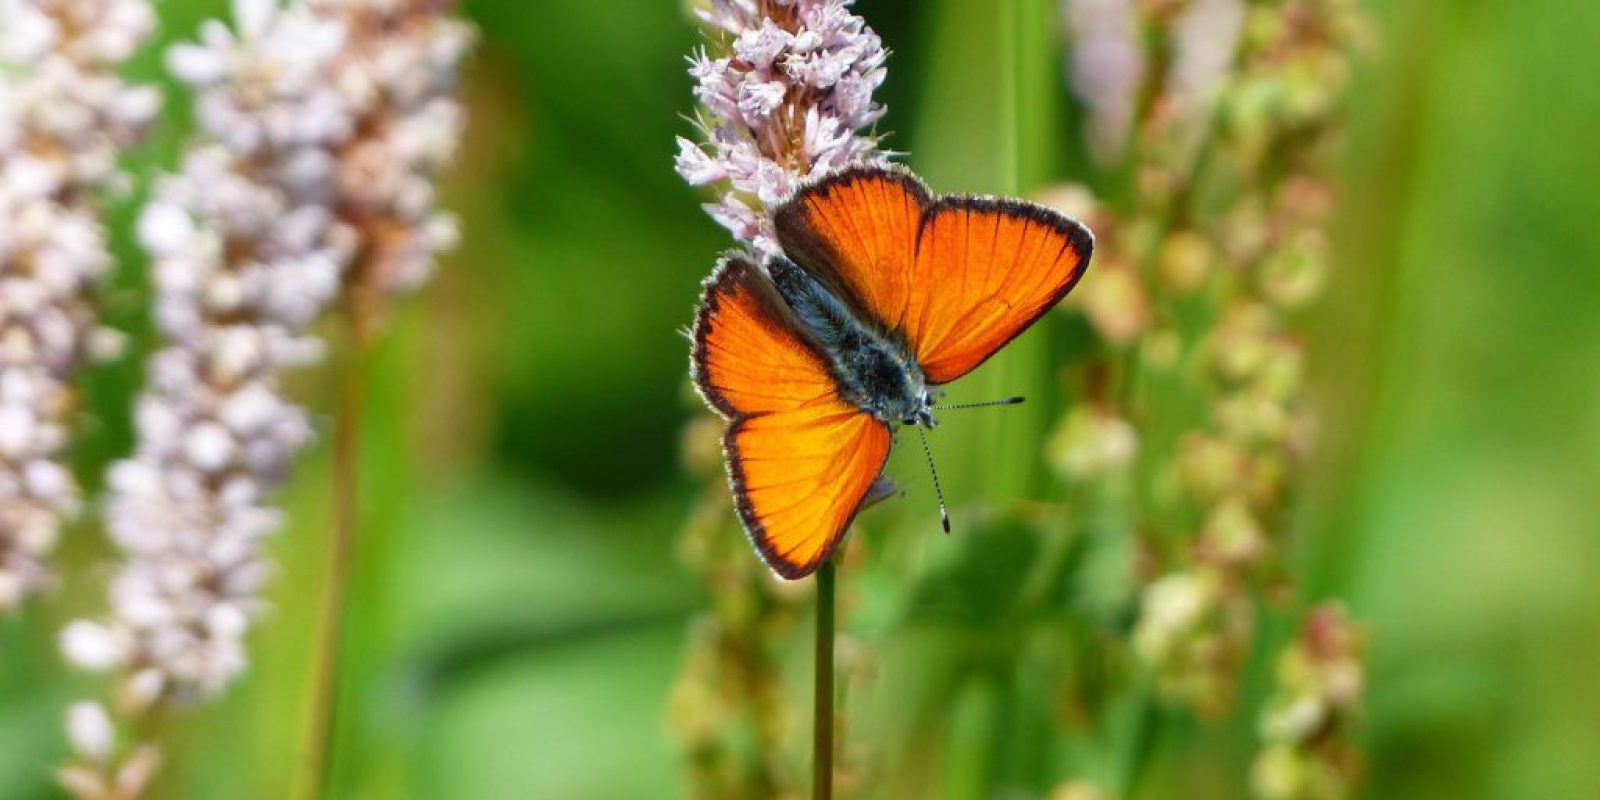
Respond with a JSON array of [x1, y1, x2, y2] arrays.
[[691, 166, 1094, 579]]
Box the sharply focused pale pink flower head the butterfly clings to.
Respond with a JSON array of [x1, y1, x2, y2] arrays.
[[677, 0, 888, 253]]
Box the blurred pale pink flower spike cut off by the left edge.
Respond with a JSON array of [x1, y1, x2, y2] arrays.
[[0, 0, 160, 611]]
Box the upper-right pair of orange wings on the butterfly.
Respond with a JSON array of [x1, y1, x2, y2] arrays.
[[774, 166, 1094, 384]]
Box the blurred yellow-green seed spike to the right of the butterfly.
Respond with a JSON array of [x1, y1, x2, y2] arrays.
[[1050, 0, 1365, 726]]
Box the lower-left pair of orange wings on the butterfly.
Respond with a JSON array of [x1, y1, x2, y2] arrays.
[[693, 258, 890, 579]]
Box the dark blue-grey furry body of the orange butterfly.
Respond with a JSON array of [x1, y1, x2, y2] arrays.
[[766, 258, 934, 427]]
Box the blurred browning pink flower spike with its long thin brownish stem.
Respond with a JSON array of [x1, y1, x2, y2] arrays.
[[301, 0, 472, 797]]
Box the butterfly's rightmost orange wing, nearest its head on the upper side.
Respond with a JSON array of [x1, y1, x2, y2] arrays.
[[901, 197, 1094, 384]]
